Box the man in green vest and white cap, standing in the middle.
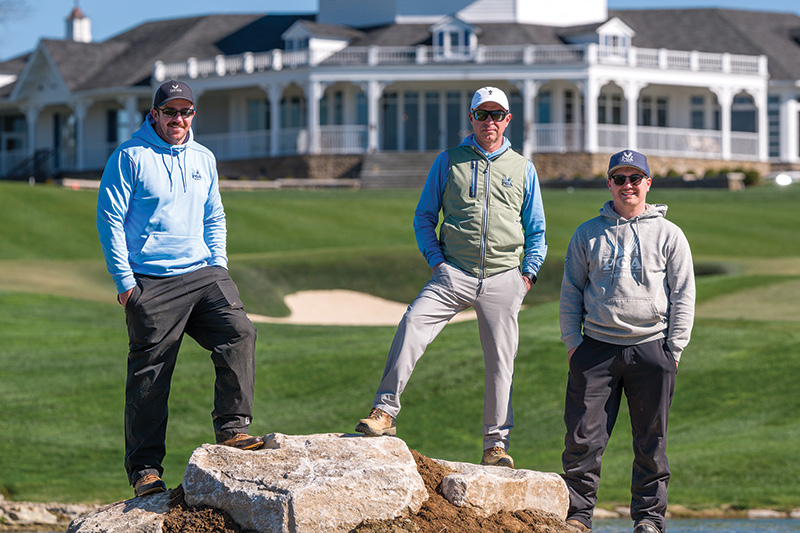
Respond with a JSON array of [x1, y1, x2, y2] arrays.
[[356, 87, 547, 468]]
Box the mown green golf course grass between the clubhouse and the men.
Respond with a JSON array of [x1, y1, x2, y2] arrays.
[[0, 181, 800, 509]]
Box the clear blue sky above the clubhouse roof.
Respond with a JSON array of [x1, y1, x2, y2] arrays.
[[0, 0, 800, 61]]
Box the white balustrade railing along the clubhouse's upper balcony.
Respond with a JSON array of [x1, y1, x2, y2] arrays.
[[153, 44, 767, 81]]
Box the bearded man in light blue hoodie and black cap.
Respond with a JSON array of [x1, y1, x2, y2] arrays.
[[97, 81, 264, 496]]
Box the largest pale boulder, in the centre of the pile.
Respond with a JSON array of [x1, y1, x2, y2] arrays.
[[183, 434, 428, 533]]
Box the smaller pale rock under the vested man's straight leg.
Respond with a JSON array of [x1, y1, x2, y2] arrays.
[[435, 459, 569, 519]]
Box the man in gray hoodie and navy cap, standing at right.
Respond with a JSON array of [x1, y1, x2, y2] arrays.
[[559, 150, 695, 533]]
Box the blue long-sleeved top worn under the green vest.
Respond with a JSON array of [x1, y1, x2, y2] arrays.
[[414, 135, 547, 275]]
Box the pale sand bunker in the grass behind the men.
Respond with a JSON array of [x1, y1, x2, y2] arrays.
[[248, 290, 475, 326]]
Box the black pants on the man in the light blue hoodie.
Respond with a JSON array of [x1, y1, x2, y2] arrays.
[[125, 267, 256, 485]]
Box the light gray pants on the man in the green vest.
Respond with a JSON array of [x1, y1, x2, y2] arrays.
[[373, 263, 527, 450]]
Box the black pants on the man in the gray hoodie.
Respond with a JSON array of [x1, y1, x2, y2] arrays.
[[562, 337, 677, 532]]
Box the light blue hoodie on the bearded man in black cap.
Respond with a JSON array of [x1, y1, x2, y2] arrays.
[[97, 116, 228, 293]]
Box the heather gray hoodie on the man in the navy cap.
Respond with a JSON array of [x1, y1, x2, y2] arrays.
[[559, 201, 695, 361]]
